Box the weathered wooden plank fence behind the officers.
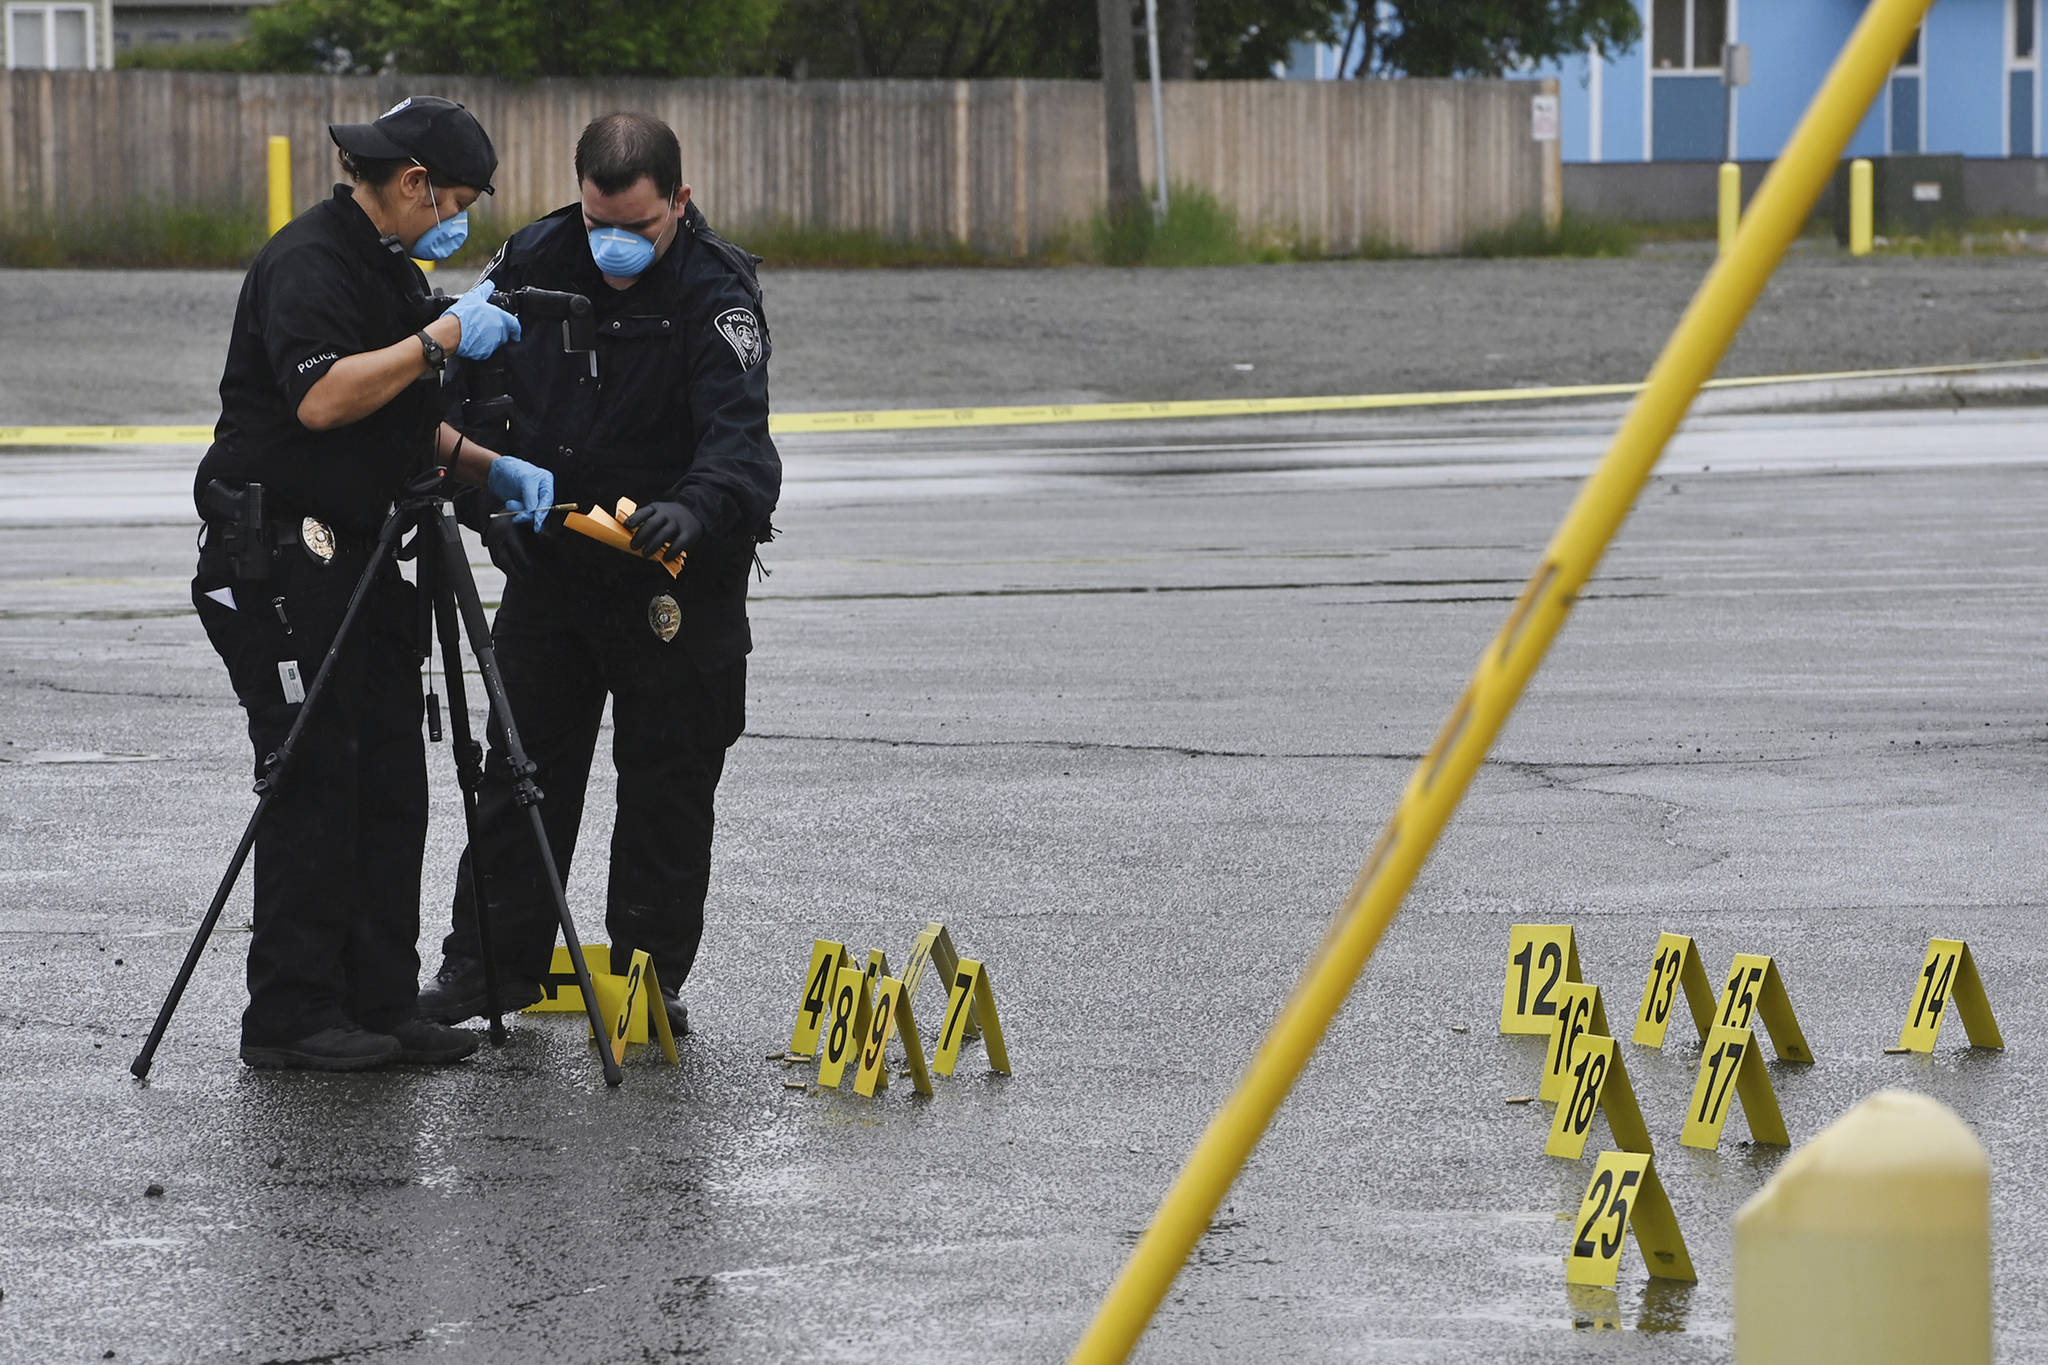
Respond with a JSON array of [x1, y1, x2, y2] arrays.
[[0, 72, 1563, 256]]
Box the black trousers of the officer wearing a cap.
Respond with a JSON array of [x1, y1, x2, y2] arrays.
[[193, 532, 426, 1046]]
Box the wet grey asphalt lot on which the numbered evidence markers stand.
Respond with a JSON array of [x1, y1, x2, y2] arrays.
[[0, 261, 2048, 1361]]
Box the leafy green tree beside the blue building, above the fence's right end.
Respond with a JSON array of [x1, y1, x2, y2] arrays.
[[1337, 0, 1642, 76]]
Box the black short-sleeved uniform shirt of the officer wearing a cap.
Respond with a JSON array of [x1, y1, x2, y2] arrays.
[[193, 184, 440, 536]]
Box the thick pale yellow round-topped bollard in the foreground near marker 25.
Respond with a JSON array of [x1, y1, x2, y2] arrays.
[[1735, 1091, 1991, 1365]]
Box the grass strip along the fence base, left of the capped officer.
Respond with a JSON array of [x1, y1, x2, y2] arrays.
[[0, 201, 266, 270]]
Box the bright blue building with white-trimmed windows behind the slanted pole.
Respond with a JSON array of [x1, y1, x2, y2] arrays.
[[1536, 0, 2044, 162]]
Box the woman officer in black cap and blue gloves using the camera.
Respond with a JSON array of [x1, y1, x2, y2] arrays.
[[193, 96, 553, 1070]]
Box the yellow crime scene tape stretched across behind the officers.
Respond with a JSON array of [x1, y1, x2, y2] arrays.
[[0, 358, 2048, 448]]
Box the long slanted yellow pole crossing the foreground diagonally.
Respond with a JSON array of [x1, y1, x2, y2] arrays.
[[1069, 0, 1933, 1365]]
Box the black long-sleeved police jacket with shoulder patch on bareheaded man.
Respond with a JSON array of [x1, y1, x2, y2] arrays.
[[471, 205, 782, 661]]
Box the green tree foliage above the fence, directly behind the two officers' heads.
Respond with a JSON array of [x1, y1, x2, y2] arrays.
[[248, 0, 776, 78]]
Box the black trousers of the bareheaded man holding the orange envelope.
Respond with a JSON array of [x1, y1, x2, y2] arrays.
[[442, 575, 745, 990]]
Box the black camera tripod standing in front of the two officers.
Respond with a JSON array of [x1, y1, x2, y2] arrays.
[[129, 470, 621, 1085]]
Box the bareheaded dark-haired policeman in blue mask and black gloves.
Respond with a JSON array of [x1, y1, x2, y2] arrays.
[[420, 113, 782, 1031]]
